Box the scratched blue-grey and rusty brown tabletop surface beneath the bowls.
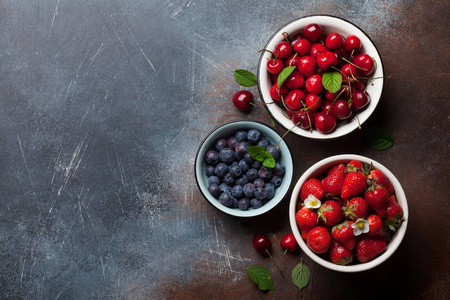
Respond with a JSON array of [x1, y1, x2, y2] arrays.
[[0, 0, 450, 299]]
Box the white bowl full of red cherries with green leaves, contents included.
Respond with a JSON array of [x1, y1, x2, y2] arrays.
[[257, 15, 384, 139]]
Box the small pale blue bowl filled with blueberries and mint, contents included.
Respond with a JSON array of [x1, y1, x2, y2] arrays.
[[195, 121, 293, 217]]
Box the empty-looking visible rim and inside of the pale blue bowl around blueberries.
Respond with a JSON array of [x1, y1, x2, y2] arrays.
[[195, 121, 294, 217]]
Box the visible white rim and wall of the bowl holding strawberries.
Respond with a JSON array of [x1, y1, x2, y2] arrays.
[[289, 154, 408, 272]]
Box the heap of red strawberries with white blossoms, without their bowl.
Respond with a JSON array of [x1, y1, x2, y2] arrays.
[[296, 160, 403, 265]]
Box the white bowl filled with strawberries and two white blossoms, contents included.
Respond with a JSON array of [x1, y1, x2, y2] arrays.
[[289, 154, 408, 272]]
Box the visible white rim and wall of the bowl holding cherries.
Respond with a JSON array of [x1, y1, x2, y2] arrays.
[[257, 15, 384, 139]]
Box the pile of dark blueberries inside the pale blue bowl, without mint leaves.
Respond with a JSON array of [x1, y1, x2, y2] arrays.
[[205, 129, 286, 210]]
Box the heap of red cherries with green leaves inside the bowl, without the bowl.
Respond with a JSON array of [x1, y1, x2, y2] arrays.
[[264, 24, 375, 133]]
